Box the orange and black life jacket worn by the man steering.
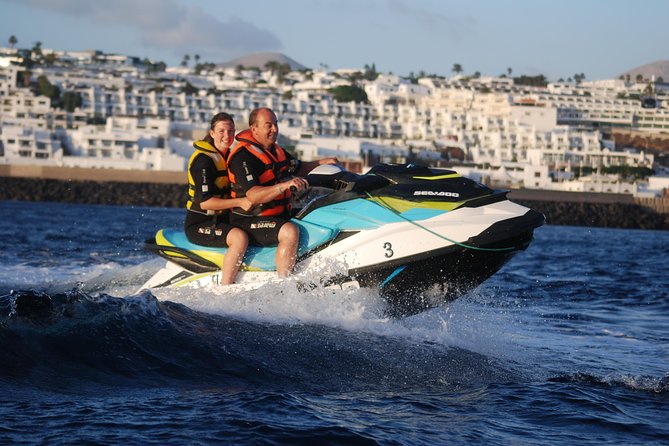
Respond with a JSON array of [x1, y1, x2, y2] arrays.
[[228, 129, 291, 216]]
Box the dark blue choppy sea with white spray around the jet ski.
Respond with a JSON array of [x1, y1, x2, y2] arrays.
[[0, 202, 669, 446]]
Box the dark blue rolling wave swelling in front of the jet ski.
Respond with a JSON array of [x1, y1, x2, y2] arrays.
[[0, 290, 518, 391]]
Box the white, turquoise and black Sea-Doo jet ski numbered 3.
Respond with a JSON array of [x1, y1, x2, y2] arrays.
[[142, 164, 545, 316]]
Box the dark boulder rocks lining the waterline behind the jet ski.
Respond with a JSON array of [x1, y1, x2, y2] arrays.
[[0, 177, 669, 230]]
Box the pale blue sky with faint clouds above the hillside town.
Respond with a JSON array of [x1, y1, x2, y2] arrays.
[[0, 0, 669, 80]]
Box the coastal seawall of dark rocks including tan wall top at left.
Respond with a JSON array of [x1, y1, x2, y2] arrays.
[[0, 166, 669, 230]]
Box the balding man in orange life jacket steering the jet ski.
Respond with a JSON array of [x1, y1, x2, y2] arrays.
[[228, 108, 337, 277]]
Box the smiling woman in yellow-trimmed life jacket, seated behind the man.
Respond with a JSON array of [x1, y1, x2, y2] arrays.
[[184, 113, 252, 284]]
